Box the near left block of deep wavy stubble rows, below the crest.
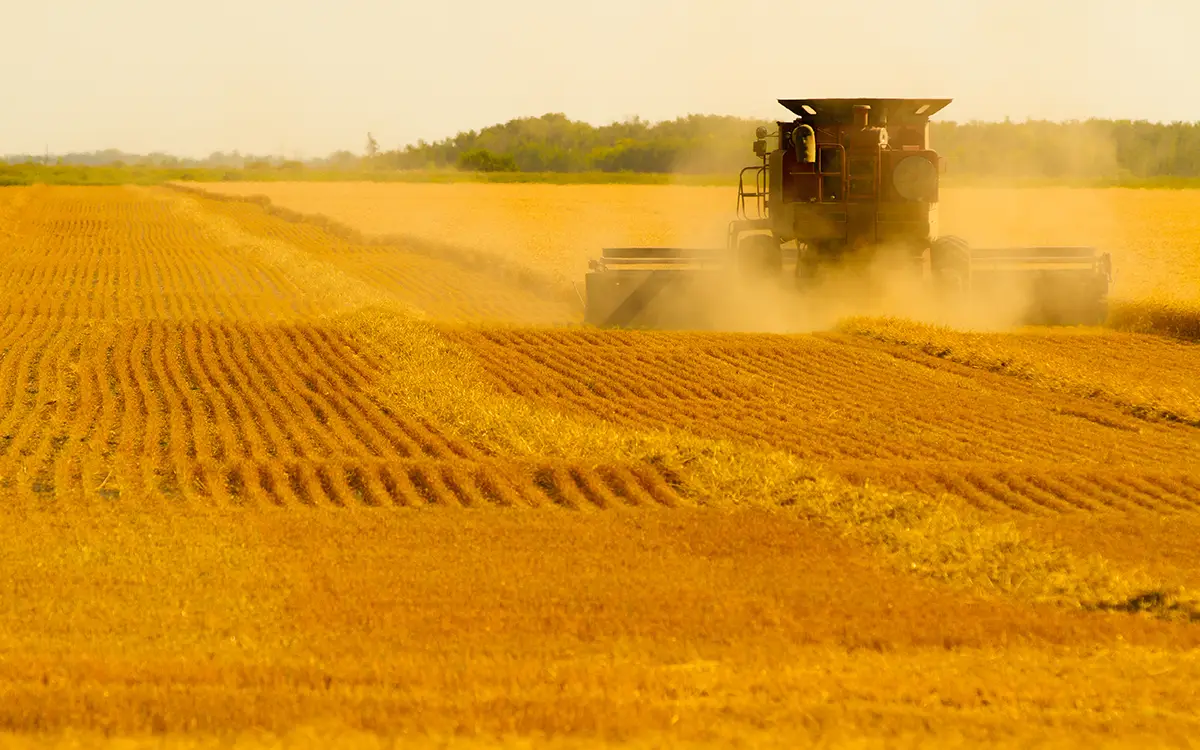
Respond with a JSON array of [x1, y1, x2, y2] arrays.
[[0, 316, 685, 506]]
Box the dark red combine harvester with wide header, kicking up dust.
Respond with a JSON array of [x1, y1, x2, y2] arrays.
[[584, 98, 1111, 328]]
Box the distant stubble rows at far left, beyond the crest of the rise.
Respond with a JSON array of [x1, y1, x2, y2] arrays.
[[0, 188, 319, 320]]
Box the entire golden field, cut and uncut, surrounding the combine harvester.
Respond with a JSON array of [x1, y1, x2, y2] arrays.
[[0, 185, 1200, 748]]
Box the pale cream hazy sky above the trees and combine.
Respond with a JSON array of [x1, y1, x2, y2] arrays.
[[0, 0, 1200, 157]]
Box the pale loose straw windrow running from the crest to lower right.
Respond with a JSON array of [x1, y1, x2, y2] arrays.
[[360, 316, 1194, 617]]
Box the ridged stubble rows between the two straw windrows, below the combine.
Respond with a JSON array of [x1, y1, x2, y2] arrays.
[[445, 329, 1200, 512]]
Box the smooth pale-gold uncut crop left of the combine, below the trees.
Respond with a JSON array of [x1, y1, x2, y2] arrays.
[[194, 182, 734, 282]]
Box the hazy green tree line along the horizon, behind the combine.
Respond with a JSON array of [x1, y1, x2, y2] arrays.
[[5, 114, 1200, 181]]
